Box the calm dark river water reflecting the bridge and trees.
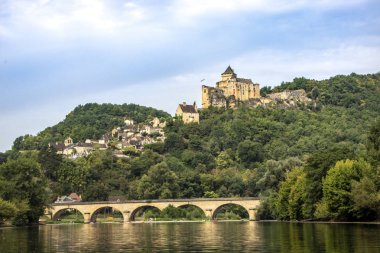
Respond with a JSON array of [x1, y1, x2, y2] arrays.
[[0, 222, 380, 253]]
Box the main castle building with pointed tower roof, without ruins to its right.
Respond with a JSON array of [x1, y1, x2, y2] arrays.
[[202, 66, 260, 108]]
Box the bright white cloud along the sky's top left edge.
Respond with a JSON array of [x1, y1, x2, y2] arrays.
[[9, 0, 149, 36]]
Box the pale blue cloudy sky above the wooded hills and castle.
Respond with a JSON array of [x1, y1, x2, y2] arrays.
[[0, 0, 380, 152]]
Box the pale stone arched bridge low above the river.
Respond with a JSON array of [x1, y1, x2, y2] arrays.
[[46, 197, 260, 223]]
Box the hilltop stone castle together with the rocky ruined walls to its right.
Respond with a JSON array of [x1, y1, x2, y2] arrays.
[[202, 66, 311, 108]]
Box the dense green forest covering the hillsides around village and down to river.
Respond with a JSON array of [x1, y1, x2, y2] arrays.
[[0, 73, 380, 224]]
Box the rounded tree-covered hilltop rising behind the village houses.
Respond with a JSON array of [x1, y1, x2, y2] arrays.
[[13, 103, 171, 150]]
